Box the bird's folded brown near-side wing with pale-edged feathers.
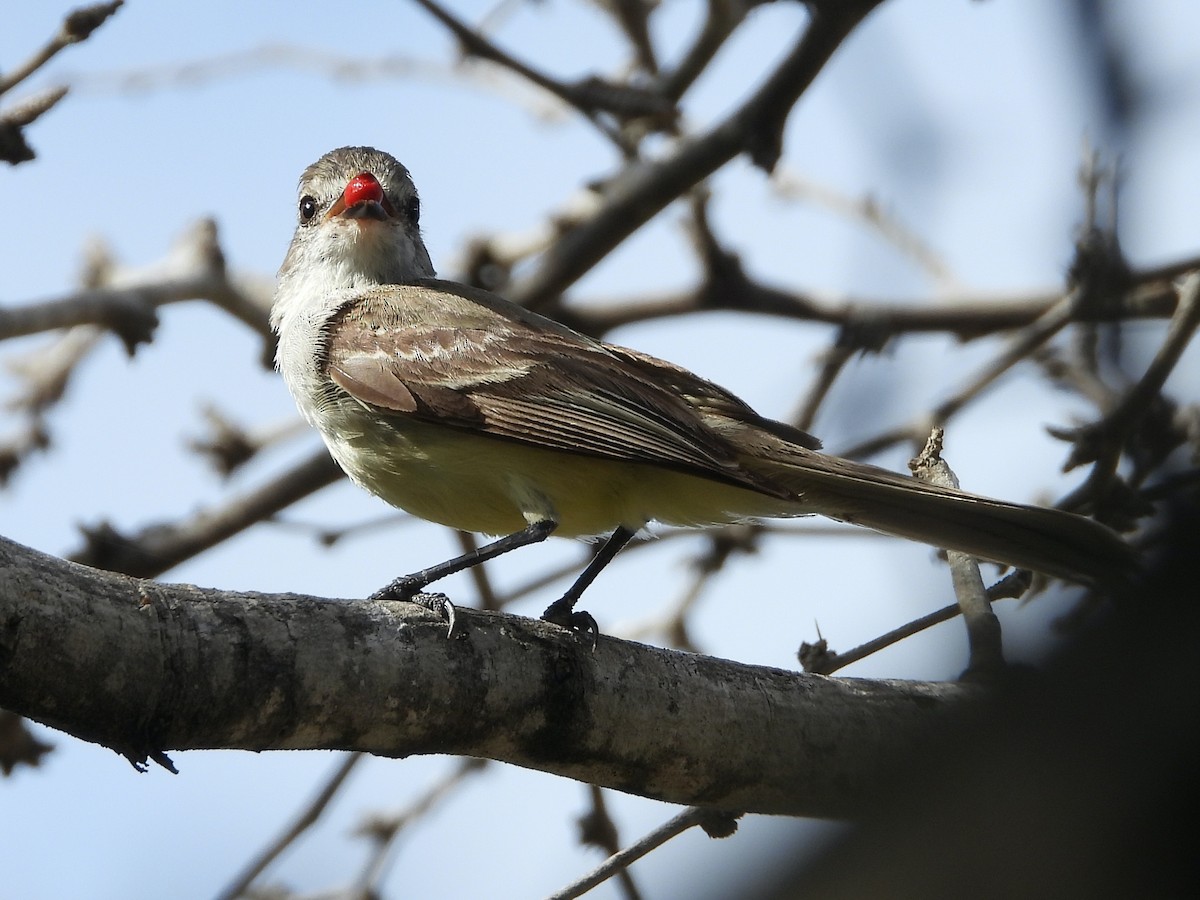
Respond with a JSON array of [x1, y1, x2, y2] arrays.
[[324, 281, 787, 496]]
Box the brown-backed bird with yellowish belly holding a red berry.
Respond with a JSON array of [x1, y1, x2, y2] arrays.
[[270, 146, 1134, 636]]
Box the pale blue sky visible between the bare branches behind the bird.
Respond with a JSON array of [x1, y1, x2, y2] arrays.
[[0, 0, 1200, 898]]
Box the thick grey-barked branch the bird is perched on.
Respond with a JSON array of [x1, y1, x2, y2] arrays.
[[0, 539, 970, 817]]
